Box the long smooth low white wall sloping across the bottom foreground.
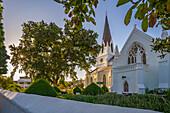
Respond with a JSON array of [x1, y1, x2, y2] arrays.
[[0, 90, 161, 113]]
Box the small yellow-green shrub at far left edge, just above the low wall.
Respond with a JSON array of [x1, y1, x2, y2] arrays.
[[0, 76, 14, 89]]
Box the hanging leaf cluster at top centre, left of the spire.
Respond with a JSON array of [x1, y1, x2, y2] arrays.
[[54, 0, 98, 28]]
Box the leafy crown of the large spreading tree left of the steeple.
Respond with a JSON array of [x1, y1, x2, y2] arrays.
[[9, 20, 100, 86]]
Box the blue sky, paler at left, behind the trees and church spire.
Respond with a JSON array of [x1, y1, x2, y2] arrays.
[[3, 0, 170, 80]]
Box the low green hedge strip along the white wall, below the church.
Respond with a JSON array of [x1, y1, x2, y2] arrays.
[[59, 94, 170, 113]]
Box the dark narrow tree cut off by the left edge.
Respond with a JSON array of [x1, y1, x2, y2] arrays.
[[0, 0, 9, 75]]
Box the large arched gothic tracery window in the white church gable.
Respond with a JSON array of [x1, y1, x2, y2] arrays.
[[128, 43, 146, 64]]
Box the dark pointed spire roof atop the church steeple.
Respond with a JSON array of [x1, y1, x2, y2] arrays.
[[103, 15, 112, 46]]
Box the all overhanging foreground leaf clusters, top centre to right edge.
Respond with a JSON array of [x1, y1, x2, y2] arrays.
[[54, 0, 170, 57]]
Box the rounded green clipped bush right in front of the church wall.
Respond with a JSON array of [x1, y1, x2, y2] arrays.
[[83, 83, 104, 96]]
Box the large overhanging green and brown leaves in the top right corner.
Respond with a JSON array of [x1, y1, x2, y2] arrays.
[[117, 0, 170, 32]]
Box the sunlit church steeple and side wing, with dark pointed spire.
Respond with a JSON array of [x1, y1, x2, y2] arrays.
[[84, 16, 115, 89]]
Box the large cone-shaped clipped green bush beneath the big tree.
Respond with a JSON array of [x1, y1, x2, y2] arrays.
[[25, 79, 57, 97]]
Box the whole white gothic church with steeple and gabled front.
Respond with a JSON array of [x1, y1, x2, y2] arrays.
[[85, 16, 170, 94]]
